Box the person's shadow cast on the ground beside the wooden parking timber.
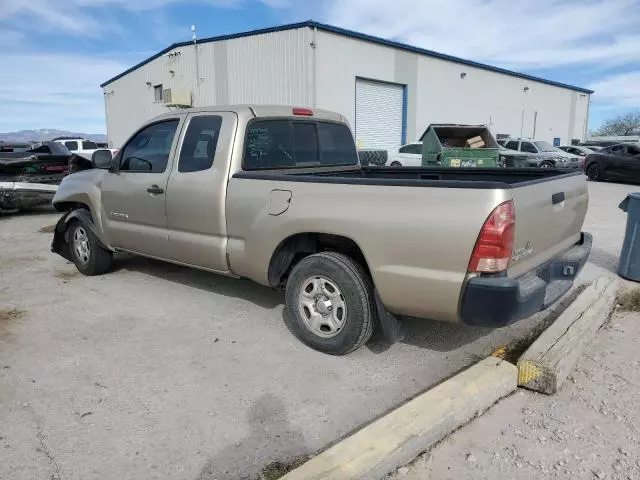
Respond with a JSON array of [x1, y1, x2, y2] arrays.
[[196, 394, 309, 480]]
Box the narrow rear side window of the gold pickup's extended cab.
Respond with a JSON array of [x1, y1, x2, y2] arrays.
[[178, 115, 222, 172]]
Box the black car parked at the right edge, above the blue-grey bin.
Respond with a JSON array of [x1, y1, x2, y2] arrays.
[[585, 143, 640, 182]]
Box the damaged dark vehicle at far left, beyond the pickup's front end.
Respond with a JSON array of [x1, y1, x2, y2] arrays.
[[0, 142, 72, 213]]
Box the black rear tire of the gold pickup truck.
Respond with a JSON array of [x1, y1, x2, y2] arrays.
[[284, 252, 378, 355]]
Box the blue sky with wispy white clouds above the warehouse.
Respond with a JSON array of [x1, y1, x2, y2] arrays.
[[0, 0, 640, 133]]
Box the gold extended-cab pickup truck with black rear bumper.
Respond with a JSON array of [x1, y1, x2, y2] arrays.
[[52, 105, 591, 355]]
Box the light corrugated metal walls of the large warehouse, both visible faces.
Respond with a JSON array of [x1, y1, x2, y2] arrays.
[[104, 27, 589, 147]]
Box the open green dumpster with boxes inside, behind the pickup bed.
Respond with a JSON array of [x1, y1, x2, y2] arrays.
[[420, 124, 500, 168]]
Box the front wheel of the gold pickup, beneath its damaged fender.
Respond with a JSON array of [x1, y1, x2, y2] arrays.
[[67, 221, 113, 276]]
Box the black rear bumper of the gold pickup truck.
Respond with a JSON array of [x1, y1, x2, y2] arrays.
[[460, 233, 593, 328]]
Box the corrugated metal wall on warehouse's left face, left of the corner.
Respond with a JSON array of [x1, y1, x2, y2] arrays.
[[104, 28, 313, 147]]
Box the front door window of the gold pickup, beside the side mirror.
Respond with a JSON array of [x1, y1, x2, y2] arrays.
[[120, 119, 179, 173]]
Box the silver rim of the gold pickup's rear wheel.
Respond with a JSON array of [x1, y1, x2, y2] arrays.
[[298, 275, 347, 338]]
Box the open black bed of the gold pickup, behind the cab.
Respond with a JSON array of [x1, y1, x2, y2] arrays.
[[234, 167, 583, 189]]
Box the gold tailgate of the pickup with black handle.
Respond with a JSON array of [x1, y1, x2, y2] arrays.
[[508, 175, 588, 277]]
